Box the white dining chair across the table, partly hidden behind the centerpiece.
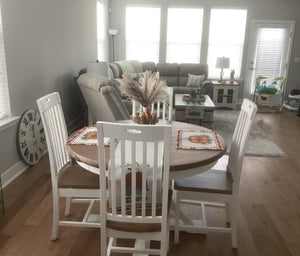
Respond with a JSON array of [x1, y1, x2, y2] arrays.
[[132, 87, 173, 121]]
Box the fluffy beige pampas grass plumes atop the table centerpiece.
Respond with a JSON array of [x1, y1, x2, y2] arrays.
[[120, 71, 170, 107]]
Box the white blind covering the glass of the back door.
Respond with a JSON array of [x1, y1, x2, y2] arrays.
[[255, 27, 290, 78]]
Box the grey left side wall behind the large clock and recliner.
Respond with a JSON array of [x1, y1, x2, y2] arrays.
[[0, 0, 97, 173]]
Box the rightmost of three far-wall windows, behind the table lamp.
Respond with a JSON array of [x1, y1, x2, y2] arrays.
[[207, 9, 247, 78]]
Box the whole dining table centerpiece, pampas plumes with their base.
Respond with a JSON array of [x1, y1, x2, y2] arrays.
[[120, 71, 169, 124]]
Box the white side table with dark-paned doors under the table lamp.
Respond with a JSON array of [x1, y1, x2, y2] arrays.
[[211, 81, 240, 109]]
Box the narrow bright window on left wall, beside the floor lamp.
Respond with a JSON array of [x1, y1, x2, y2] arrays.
[[97, 1, 107, 61]]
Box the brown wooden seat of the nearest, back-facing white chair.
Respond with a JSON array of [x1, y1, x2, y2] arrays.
[[106, 190, 173, 232]]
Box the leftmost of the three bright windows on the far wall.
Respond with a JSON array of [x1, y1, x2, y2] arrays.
[[126, 7, 160, 62]]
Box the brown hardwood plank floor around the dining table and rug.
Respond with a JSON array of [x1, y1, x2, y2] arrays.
[[0, 111, 300, 256]]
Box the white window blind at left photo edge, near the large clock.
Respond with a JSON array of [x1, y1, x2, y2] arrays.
[[0, 8, 10, 120]]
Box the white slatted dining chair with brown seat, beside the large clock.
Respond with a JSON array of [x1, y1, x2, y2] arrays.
[[37, 92, 100, 240]]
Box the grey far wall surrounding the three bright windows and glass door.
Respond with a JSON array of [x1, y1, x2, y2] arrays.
[[110, 0, 300, 98]]
